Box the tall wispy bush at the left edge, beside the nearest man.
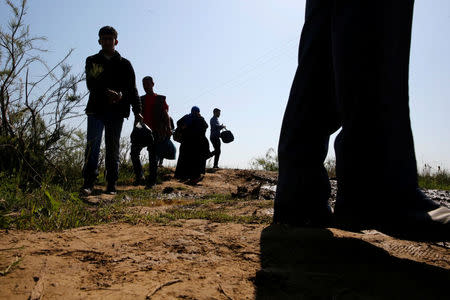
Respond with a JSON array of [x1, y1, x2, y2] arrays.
[[0, 0, 84, 190]]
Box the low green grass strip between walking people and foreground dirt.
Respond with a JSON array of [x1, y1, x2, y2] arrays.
[[0, 171, 271, 231]]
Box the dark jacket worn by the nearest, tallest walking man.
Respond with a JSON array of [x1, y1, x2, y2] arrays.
[[86, 51, 142, 118]]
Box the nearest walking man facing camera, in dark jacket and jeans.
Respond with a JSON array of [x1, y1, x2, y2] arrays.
[[81, 26, 142, 196]]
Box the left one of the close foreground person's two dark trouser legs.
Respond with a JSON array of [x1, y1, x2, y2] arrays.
[[274, 0, 340, 225]]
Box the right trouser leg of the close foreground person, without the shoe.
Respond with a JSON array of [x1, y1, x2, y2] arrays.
[[332, 0, 417, 211]]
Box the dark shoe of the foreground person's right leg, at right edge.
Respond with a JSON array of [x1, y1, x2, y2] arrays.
[[335, 189, 450, 241]]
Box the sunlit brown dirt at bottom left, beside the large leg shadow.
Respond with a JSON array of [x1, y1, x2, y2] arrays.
[[0, 220, 262, 299]]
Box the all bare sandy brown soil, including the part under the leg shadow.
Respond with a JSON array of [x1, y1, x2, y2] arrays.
[[0, 170, 450, 299]]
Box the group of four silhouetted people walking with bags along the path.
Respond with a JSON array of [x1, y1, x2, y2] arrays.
[[81, 26, 229, 195]]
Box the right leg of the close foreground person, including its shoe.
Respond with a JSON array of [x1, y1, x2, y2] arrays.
[[333, 0, 450, 238]]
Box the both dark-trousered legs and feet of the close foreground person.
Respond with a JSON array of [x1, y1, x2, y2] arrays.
[[274, 0, 450, 239]]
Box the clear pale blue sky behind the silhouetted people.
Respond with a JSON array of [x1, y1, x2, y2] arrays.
[[0, 0, 450, 169]]
